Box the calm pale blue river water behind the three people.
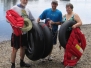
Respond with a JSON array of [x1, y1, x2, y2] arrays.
[[0, 0, 91, 42]]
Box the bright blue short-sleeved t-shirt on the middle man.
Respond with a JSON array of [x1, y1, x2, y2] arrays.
[[39, 8, 62, 31]]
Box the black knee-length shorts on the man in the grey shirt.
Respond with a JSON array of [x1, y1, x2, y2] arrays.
[[11, 33, 28, 49]]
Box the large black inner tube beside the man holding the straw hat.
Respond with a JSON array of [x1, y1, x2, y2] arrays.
[[26, 22, 44, 61]]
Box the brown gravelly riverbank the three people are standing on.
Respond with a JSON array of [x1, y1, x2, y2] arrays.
[[0, 24, 91, 68]]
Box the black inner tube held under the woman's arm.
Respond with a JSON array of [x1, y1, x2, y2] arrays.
[[58, 21, 76, 48]]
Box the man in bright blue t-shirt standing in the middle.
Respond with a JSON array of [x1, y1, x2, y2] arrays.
[[37, 0, 62, 60]]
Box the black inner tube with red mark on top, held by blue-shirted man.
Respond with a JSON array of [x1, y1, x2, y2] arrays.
[[39, 22, 53, 58]]
